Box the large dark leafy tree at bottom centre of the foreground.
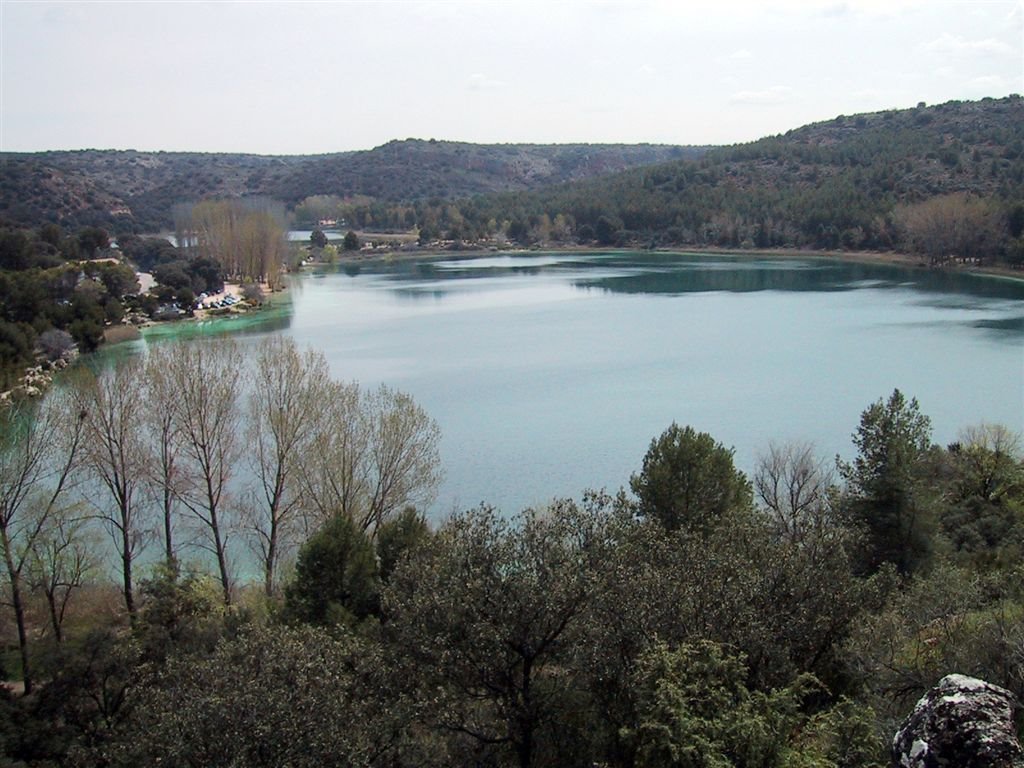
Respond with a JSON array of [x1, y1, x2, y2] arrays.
[[384, 496, 612, 766]]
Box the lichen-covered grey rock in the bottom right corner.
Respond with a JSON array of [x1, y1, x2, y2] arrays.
[[893, 675, 1024, 768]]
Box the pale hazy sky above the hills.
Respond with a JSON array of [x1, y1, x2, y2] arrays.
[[0, 0, 1024, 155]]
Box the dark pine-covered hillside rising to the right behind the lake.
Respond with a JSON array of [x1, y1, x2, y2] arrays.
[[370, 95, 1024, 262]]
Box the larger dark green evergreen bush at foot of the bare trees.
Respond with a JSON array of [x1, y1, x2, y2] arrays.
[[285, 514, 380, 626]]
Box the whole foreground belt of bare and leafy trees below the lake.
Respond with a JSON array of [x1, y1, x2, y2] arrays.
[[0, 339, 1024, 768]]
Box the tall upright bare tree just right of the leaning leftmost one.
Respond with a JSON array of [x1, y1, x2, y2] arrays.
[[75, 358, 147, 618]]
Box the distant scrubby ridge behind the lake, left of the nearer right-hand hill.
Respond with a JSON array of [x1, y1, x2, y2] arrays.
[[0, 139, 705, 231]]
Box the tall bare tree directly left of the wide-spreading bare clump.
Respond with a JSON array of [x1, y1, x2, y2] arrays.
[[249, 337, 332, 595]]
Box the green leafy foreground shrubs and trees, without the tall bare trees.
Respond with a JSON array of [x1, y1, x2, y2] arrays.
[[0, 374, 1024, 768]]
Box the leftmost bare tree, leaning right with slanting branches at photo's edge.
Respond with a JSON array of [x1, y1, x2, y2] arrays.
[[0, 390, 85, 693]]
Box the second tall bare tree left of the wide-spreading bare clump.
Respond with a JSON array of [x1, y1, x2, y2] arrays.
[[165, 339, 243, 603]]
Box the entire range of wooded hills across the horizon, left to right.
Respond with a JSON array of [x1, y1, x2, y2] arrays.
[[0, 95, 1024, 263]]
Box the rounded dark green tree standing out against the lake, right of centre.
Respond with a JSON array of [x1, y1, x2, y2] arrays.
[[630, 423, 753, 531]]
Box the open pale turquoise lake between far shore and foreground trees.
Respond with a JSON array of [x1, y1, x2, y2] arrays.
[[140, 253, 1024, 517]]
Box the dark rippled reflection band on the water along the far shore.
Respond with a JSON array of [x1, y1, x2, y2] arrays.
[[333, 252, 1024, 334]]
